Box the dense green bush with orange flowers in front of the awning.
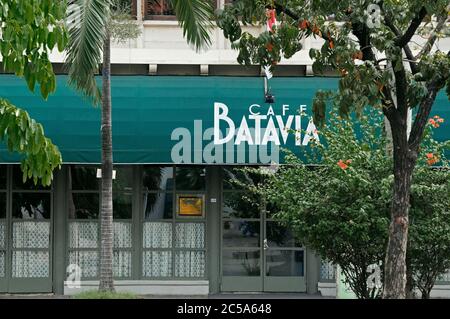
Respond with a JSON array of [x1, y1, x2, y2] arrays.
[[267, 113, 392, 298]]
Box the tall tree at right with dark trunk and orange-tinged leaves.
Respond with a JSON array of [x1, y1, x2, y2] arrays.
[[218, 0, 450, 298]]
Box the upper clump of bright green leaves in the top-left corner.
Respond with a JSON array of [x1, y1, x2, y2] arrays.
[[0, 0, 67, 98]]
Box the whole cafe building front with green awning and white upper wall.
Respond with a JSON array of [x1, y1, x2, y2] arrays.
[[0, 0, 450, 296]]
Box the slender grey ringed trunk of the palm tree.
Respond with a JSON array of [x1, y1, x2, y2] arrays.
[[99, 31, 114, 291]]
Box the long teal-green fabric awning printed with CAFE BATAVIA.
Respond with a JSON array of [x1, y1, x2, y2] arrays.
[[0, 74, 450, 165]]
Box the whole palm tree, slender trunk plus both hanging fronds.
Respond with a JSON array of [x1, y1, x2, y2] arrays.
[[66, 0, 213, 291]]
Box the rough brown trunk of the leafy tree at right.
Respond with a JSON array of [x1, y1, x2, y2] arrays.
[[383, 121, 414, 299]]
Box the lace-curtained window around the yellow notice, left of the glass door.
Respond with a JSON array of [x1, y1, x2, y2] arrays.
[[142, 166, 206, 278]]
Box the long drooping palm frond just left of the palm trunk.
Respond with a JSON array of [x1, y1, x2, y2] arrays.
[[66, 0, 111, 103]]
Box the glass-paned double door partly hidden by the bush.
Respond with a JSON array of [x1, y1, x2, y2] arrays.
[[221, 169, 306, 292]]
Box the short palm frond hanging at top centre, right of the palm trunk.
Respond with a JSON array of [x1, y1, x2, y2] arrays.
[[171, 0, 213, 51]]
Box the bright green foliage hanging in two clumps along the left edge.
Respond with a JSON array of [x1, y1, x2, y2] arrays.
[[0, 0, 67, 185]]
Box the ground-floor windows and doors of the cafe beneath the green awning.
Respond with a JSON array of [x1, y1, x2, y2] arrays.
[[0, 165, 319, 295]]
